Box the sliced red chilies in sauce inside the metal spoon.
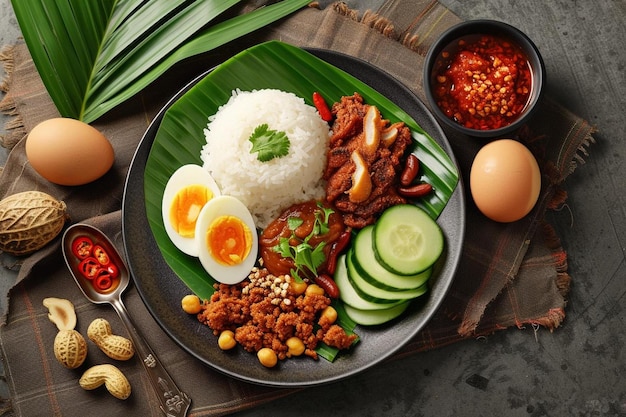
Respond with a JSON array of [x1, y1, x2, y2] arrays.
[[72, 236, 120, 293]]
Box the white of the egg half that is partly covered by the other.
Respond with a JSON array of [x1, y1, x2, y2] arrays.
[[161, 164, 221, 256]]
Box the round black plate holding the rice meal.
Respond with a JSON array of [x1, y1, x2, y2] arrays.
[[122, 49, 465, 387]]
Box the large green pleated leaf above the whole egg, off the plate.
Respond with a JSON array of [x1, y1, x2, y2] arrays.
[[11, 0, 310, 123]]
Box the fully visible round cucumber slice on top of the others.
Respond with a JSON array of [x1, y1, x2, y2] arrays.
[[373, 204, 443, 275]]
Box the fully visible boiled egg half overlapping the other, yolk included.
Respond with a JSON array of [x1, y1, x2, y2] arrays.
[[196, 196, 259, 285]]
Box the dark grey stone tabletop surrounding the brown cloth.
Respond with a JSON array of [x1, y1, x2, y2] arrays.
[[0, 0, 626, 417]]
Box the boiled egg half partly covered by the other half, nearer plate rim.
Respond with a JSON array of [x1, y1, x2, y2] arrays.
[[161, 164, 220, 256]]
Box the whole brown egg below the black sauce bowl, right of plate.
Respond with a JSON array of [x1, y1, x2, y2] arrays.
[[470, 139, 541, 223]]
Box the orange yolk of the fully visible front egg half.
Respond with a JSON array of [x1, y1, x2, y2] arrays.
[[207, 215, 252, 266]]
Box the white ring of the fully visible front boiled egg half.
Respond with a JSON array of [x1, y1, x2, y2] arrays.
[[196, 196, 259, 285]]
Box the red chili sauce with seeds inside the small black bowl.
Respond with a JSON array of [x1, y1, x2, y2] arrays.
[[432, 35, 532, 130]]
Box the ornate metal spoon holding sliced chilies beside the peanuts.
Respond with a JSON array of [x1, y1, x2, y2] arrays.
[[63, 224, 191, 417]]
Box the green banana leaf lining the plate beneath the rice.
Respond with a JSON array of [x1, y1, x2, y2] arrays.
[[144, 41, 458, 298]]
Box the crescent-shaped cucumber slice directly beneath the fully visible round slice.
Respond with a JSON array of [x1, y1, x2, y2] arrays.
[[352, 225, 432, 291]]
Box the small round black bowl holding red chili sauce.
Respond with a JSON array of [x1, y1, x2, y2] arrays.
[[424, 20, 546, 137]]
